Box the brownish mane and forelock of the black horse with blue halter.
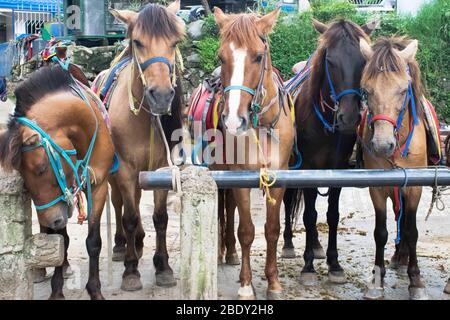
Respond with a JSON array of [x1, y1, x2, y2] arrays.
[[297, 19, 370, 122]]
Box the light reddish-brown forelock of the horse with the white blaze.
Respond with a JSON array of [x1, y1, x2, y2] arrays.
[[220, 13, 263, 47]]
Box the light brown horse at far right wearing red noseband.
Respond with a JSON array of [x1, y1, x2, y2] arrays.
[[361, 38, 428, 299]]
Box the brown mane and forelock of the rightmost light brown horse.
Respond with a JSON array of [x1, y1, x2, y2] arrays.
[[363, 37, 425, 102]]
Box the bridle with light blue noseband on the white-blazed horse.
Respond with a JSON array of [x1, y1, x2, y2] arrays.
[[222, 37, 284, 132]]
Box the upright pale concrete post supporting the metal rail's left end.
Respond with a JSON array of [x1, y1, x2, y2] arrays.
[[180, 166, 218, 300]]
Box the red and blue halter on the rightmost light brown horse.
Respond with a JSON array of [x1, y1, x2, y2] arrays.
[[368, 66, 419, 157]]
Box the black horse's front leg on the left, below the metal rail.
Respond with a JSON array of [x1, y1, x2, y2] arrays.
[[300, 188, 318, 286]]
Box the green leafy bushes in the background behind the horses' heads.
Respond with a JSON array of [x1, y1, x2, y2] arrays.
[[195, 0, 450, 123]]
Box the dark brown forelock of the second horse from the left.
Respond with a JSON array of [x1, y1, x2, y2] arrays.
[[128, 3, 185, 39]]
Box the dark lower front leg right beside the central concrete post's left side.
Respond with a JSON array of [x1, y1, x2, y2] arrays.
[[153, 191, 177, 287]]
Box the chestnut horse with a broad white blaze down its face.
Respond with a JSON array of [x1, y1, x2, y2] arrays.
[[214, 8, 294, 299]]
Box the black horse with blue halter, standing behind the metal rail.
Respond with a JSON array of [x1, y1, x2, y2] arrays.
[[282, 19, 374, 285]]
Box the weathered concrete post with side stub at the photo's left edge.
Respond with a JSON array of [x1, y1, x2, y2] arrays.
[[0, 170, 64, 300]]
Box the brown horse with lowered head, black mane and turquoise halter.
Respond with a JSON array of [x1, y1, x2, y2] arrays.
[[0, 67, 114, 299]]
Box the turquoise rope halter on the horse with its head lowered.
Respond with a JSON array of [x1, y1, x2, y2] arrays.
[[17, 81, 99, 219]]
